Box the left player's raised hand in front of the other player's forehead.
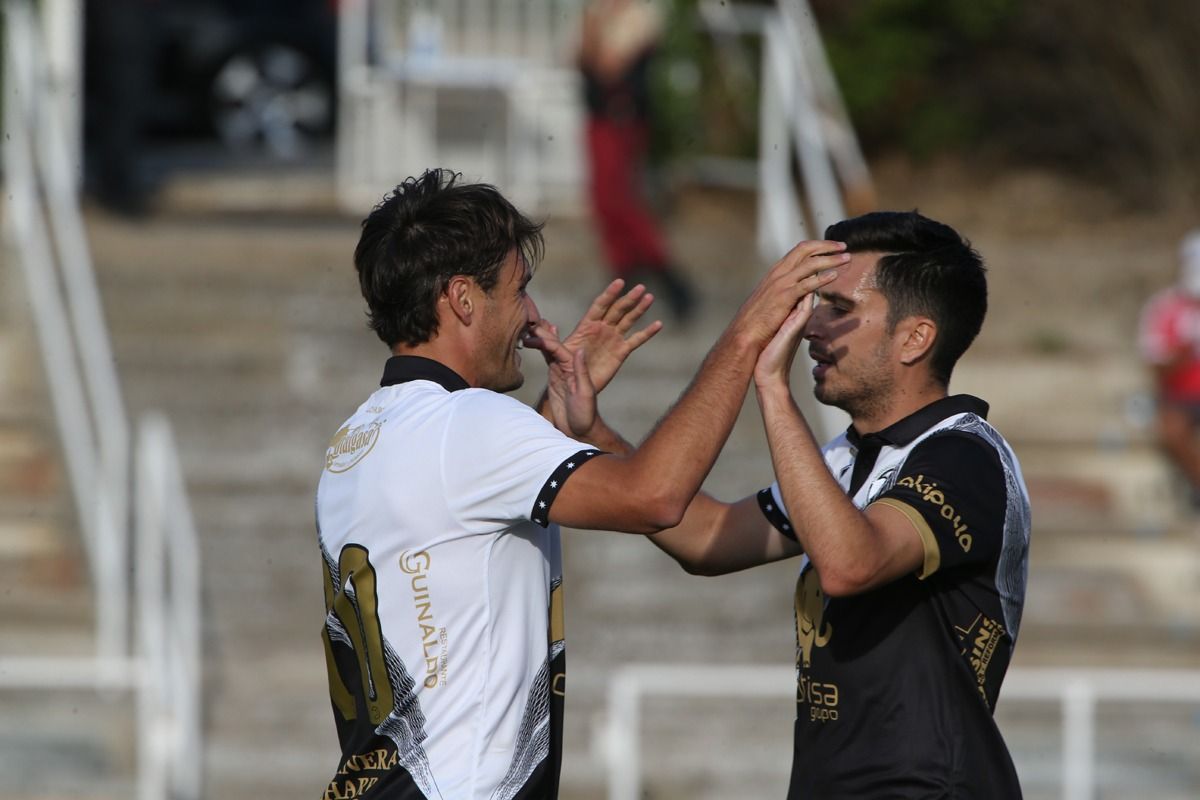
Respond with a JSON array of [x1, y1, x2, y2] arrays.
[[730, 240, 850, 350]]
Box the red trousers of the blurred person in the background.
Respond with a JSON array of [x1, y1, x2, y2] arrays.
[[588, 118, 668, 277]]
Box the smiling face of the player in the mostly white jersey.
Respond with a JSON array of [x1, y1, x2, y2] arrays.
[[480, 251, 541, 392]]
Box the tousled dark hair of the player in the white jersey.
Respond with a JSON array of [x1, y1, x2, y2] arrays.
[[354, 169, 544, 347]]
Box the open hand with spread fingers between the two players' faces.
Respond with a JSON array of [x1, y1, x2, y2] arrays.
[[563, 278, 662, 392]]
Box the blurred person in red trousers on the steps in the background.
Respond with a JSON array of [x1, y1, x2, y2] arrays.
[[578, 0, 696, 320]]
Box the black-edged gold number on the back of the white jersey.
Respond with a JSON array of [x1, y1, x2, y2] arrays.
[[322, 545, 395, 726]]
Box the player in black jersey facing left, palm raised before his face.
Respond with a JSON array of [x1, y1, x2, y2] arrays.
[[551, 212, 1031, 800]]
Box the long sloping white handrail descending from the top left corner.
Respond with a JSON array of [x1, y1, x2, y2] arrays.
[[5, 1, 128, 658]]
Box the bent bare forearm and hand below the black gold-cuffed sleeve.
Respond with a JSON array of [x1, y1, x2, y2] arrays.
[[755, 296, 924, 597]]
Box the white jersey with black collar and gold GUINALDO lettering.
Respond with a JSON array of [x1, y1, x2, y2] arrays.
[[317, 356, 599, 800]]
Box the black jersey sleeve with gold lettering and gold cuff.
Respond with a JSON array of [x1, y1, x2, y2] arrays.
[[871, 432, 1007, 578]]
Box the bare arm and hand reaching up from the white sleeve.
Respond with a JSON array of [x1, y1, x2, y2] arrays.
[[551, 241, 848, 533]]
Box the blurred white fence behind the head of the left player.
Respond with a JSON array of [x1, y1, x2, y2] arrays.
[[337, 0, 582, 212]]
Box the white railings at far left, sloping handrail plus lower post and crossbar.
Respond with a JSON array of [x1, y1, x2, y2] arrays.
[[0, 0, 202, 800]]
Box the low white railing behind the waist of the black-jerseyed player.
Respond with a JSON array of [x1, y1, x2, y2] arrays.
[[600, 663, 1200, 800]]
